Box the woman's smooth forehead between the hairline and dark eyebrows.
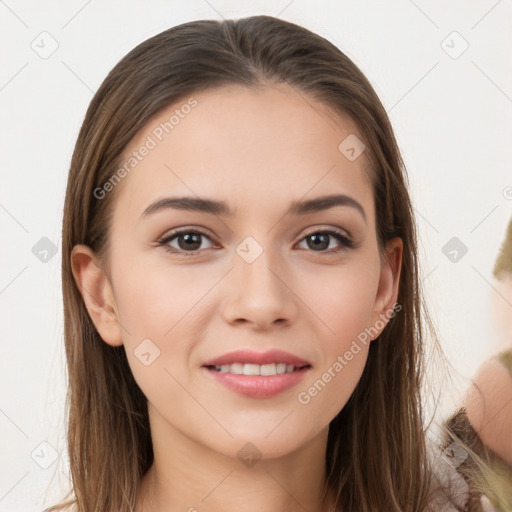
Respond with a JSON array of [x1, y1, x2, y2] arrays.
[[116, 84, 373, 224]]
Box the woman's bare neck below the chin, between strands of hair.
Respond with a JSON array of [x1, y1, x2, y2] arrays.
[[135, 404, 334, 512]]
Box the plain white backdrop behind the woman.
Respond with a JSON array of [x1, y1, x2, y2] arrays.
[[0, 0, 512, 512]]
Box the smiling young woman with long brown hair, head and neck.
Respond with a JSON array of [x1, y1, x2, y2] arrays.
[[45, 16, 492, 512]]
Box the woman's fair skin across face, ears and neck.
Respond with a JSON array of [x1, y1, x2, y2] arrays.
[[72, 85, 402, 512]]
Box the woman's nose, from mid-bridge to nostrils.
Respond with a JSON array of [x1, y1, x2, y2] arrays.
[[223, 251, 299, 330]]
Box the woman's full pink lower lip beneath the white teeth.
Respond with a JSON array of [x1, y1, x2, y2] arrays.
[[203, 366, 311, 398]]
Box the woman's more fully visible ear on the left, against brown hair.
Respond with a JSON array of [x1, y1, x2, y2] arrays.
[[71, 244, 123, 347]]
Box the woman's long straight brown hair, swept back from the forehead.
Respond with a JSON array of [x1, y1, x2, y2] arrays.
[[48, 16, 452, 512]]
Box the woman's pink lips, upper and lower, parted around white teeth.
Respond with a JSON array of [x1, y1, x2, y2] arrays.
[[203, 350, 311, 398]]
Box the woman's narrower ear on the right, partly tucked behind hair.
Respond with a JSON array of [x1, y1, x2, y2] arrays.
[[371, 237, 403, 340]]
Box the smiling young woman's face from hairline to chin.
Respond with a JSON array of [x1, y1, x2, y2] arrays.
[[79, 85, 401, 457]]
